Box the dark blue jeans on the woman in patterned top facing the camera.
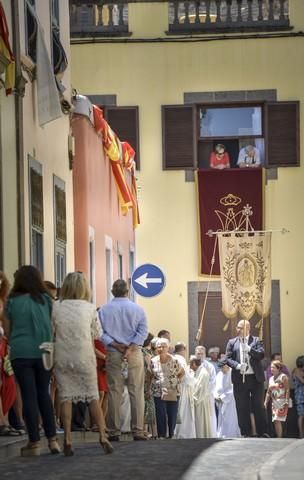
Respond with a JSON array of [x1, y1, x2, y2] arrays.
[[154, 397, 178, 438]]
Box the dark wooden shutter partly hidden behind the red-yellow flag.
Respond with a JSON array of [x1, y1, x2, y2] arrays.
[[103, 106, 140, 170]]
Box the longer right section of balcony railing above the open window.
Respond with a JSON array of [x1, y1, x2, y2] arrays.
[[169, 0, 290, 34]]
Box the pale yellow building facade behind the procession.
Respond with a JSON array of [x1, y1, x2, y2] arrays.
[[70, 0, 304, 366]]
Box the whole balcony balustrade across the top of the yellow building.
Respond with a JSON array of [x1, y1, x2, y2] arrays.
[[70, 0, 292, 39]]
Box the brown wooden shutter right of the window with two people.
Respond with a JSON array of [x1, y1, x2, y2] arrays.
[[266, 101, 300, 167]]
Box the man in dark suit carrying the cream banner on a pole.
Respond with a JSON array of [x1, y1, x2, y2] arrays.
[[226, 320, 267, 437]]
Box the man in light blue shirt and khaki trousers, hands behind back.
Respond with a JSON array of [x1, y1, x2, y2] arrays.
[[98, 280, 148, 441]]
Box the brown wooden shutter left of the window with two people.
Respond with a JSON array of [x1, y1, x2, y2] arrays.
[[162, 105, 197, 170]]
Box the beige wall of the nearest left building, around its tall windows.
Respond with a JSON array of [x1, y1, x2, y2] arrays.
[[19, 0, 74, 281]]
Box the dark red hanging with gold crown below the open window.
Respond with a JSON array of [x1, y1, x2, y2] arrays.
[[197, 168, 264, 275]]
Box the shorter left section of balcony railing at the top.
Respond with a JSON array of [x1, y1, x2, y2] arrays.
[[70, 0, 129, 38]]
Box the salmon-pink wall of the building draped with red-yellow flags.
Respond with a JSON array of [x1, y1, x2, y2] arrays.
[[72, 114, 135, 305]]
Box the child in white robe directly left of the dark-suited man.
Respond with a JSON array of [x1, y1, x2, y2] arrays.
[[215, 360, 241, 438]]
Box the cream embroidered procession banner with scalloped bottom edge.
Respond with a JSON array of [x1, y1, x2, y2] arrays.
[[219, 233, 271, 320]]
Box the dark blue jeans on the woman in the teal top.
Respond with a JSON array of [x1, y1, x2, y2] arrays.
[[12, 358, 56, 442]]
